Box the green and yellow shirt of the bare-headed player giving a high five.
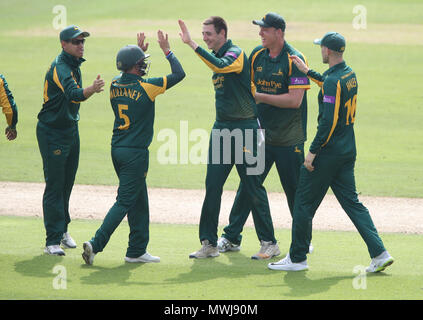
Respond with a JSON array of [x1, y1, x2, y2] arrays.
[[195, 40, 257, 121]]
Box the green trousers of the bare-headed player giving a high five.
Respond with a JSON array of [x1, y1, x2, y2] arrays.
[[199, 119, 273, 246]]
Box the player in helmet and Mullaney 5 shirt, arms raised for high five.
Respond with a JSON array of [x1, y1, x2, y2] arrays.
[[82, 30, 185, 265]]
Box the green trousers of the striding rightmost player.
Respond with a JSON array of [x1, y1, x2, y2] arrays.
[[289, 155, 385, 262]]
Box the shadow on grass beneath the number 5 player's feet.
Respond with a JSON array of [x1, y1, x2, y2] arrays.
[[81, 263, 155, 286]]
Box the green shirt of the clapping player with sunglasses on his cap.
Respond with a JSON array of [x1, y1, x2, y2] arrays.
[[38, 51, 86, 129]]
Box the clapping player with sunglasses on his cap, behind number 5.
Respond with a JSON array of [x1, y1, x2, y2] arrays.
[[37, 25, 104, 256]]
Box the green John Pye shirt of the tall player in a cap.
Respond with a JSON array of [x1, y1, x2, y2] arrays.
[[249, 41, 310, 146]]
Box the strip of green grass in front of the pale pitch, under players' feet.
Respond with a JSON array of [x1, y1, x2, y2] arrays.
[[0, 216, 423, 300]]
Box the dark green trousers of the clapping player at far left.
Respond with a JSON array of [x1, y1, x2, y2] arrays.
[[36, 121, 79, 246]]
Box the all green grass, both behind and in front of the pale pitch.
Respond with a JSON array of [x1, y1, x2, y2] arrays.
[[0, 0, 423, 300]]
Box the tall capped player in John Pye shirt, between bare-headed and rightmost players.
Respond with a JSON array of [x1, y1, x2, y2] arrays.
[[218, 12, 310, 259]]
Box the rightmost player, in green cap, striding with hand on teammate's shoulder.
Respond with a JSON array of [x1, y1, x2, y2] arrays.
[[268, 32, 394, 272]]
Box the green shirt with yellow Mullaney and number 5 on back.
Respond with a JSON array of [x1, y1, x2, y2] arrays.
[[110, 73, 167, 148]]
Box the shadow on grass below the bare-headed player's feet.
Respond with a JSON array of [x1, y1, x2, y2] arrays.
[[164, 252, 268, 284]]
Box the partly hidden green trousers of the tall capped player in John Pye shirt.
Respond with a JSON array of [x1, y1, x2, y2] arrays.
[[222, 143, 304, 245]]
